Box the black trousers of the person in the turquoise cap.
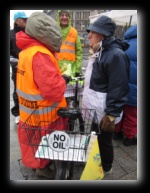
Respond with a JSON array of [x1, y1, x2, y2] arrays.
[[11, 67, 19, 117]]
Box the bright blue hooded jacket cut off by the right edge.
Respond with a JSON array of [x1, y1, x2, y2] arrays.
[[124, 25, 137, 106]]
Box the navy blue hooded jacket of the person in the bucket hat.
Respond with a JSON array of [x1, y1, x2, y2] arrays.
[[90, 37, 130, 117]]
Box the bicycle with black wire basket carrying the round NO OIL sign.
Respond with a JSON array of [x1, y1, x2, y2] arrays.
[[22, 77, 99, 180]]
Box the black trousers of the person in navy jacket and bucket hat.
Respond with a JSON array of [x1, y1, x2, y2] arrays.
[[92, 123, 114, 171]]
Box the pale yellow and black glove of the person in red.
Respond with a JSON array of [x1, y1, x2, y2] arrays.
[[61, 63, 71, 84]]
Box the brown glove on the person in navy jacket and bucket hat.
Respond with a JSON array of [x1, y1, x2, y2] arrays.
[[99, 115, 115, 132]]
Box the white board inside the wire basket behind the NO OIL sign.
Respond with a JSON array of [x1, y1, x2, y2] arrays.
[[35, 134, 88, 162]]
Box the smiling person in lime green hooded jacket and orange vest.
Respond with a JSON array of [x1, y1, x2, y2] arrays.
[[57, 10, 83, 81]]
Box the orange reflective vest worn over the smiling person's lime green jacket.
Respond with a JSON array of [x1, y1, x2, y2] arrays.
[[58, 27, 77, 61]]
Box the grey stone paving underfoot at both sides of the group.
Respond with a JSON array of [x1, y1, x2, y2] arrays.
[[10, 46, 139, 184]]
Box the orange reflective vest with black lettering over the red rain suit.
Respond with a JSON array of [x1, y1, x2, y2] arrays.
[[17, 46, 66, 125]]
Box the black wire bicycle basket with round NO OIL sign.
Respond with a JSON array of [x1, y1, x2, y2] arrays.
[[22, 107, 97, 162]]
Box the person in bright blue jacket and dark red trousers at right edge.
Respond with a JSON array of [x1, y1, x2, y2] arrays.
[[113, 25, 137, 146]]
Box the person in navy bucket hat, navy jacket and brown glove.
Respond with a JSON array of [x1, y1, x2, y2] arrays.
[[82, 16, 130, 175]]
